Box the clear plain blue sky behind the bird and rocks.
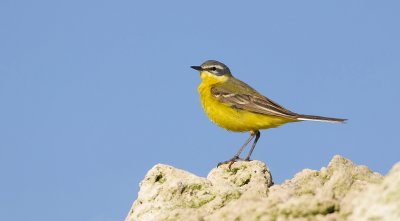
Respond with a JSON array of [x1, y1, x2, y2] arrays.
[[0, 0, 400, 221]]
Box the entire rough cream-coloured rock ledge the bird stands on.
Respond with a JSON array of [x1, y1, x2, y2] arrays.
[[125, 156, 400, 221]]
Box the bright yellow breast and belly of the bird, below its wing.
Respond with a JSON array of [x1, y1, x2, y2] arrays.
[[198, 82, 294, 132]]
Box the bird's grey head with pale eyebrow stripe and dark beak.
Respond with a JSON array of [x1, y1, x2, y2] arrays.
[[191, 60, 232, 78]]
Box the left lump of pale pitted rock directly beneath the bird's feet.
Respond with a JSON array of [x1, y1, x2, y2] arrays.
[[126, 161, 272, 221]]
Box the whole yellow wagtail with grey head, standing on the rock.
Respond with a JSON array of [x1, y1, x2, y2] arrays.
[[191, 60, 346, 167]]
